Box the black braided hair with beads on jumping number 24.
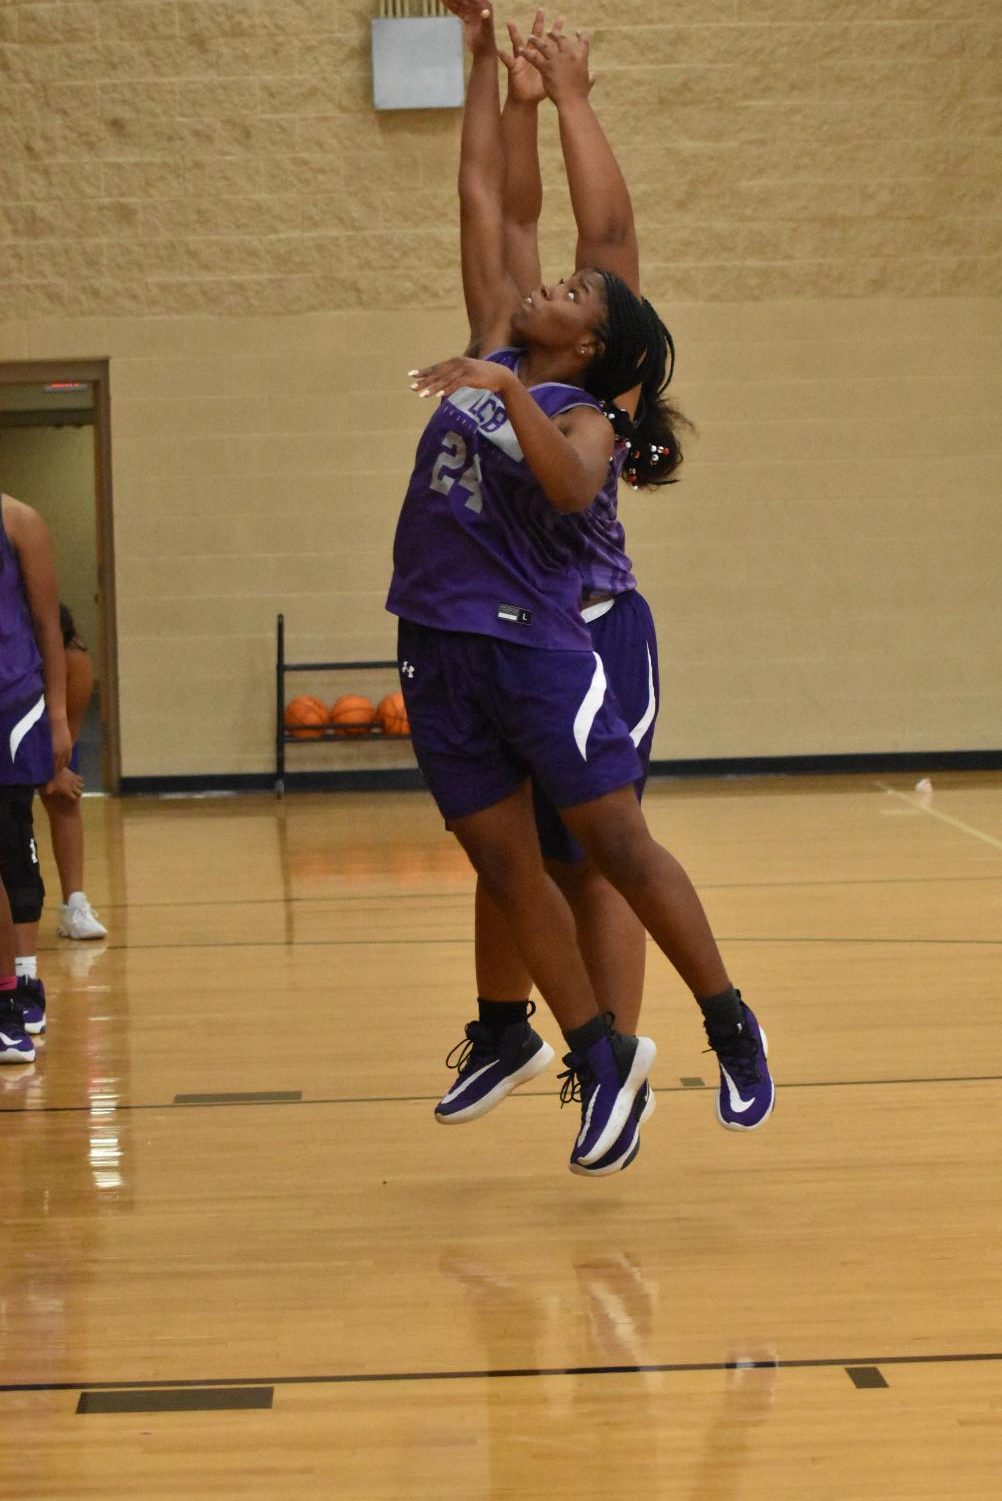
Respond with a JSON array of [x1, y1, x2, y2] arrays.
[[582, 272, 692, 489]]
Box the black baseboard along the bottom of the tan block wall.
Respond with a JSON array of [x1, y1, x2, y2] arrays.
[[120, 751, 1002, 797]]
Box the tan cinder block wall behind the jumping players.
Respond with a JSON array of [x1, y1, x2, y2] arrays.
[[0, 0, 1002, 776]]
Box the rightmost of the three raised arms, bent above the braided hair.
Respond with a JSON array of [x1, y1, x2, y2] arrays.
[[524, 32, 641, 293]]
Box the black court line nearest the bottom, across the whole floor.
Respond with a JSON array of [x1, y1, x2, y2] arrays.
[[0, 1349, 1002, 1394]]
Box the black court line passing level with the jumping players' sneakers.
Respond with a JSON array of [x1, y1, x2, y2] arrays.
[[0, 1073, 1002, 1115]]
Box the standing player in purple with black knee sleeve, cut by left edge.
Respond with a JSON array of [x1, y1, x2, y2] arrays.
[[0, 495, 72, 1061]]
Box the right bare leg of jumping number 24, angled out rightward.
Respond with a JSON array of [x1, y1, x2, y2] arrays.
[[561, 787, 731, 1000]]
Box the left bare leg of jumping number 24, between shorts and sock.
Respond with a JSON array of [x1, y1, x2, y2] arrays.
[[450, 782, 599, 1033]]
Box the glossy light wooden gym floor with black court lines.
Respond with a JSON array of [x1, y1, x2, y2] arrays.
[[0, 775, 1002, 1501]]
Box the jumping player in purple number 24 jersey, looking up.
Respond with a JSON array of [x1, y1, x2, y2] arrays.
[[389, 5, 773, 1168]]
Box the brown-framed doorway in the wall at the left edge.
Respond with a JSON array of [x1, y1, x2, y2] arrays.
[[0, 360, 122, 793]]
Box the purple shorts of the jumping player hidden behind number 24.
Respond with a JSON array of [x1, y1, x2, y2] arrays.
[[533, 590, 662, 863]]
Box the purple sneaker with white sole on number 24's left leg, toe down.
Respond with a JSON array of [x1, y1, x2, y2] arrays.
[[560, 1027, 657, 1171]]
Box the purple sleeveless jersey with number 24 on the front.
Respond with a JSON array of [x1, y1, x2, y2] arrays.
[[387, 350, 629, 651]]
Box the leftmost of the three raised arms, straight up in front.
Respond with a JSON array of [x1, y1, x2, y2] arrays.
[[446, 0, 519, 354]]
